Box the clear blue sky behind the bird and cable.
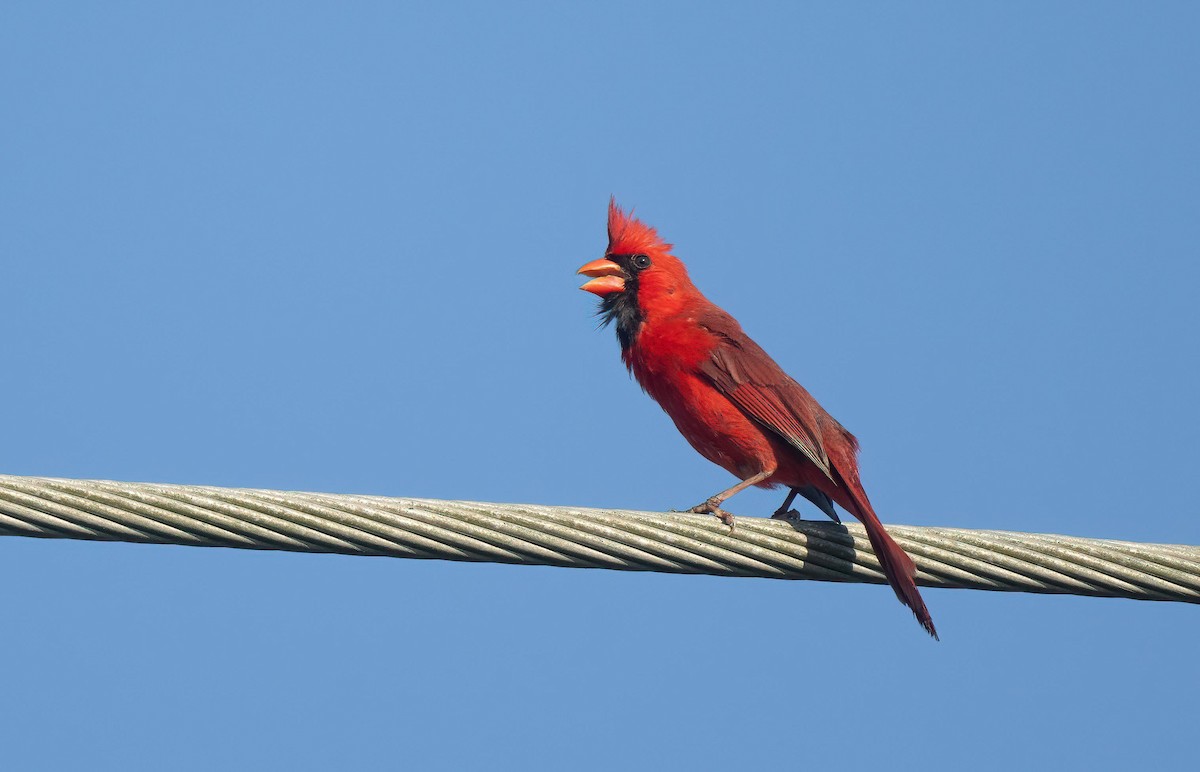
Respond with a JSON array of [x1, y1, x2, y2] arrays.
[[0, 2, 1200, 770]]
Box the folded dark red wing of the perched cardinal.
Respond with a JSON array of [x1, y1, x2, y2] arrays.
[[700, 312, 832, 479]]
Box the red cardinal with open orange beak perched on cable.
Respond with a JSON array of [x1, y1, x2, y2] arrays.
[[578, 202, 937, 639]]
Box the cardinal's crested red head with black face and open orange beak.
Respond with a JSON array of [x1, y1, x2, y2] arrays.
[[578, 199, 696, 348]]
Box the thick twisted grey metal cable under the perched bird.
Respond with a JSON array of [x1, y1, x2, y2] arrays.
[[0, 474, 1200, 603]]
